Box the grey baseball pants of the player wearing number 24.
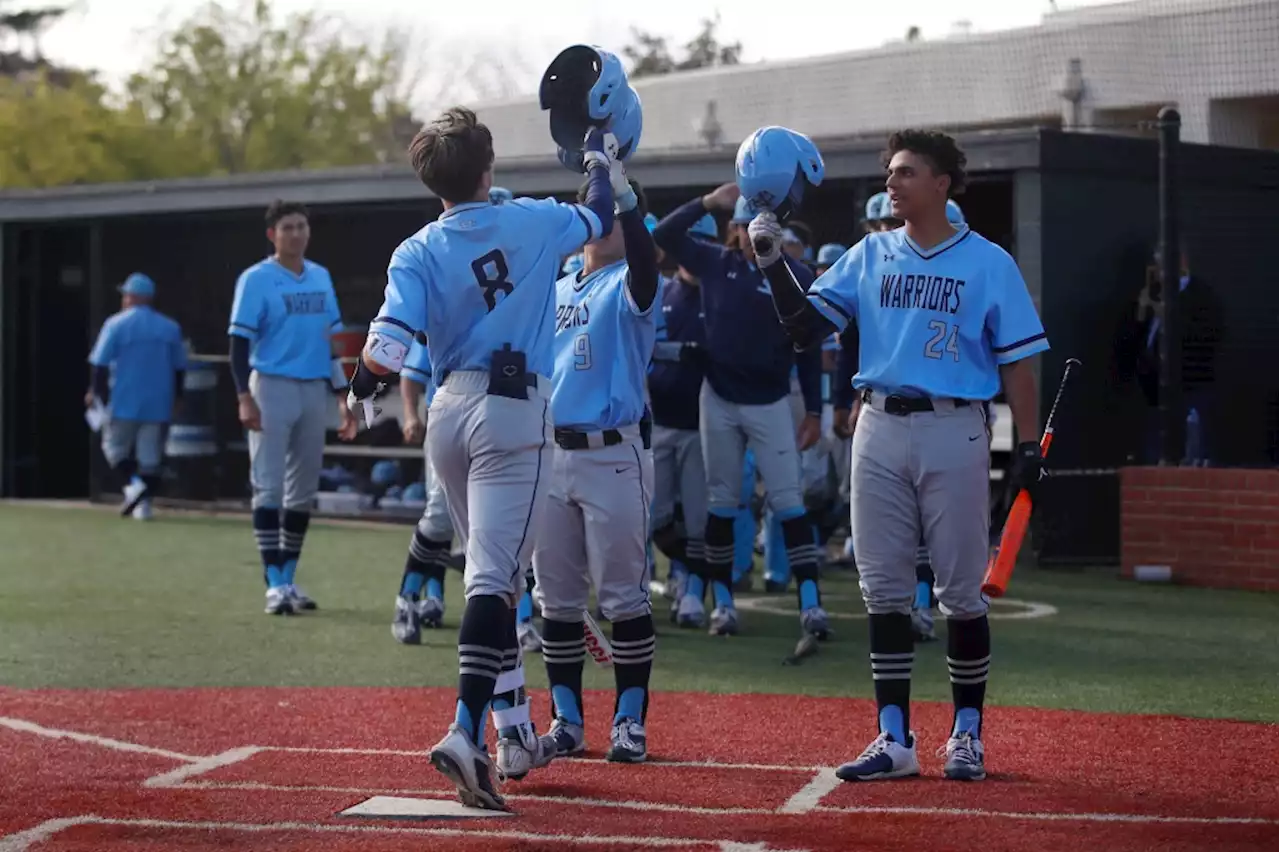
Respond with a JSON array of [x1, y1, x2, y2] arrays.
[[851, 398, 991, 619]]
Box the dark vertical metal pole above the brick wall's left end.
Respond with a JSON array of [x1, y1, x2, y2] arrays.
[[1157, 106, 1187, 464]]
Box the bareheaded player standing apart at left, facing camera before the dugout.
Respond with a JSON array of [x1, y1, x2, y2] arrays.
[[227, 201, 357, 615]]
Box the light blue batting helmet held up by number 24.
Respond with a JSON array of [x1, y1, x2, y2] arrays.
[[733, 125, 826, 221]]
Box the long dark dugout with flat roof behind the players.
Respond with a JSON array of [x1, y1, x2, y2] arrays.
[[0, 129, 1280, 562]]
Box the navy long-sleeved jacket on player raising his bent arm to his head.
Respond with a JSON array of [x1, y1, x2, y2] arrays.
[[653, 198, 822, 414]]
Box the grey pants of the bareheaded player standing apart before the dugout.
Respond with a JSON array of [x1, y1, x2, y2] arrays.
[[248, 371, 325, 512]]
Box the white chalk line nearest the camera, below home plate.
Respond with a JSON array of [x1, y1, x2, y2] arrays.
[[0, 815, 741, 852]]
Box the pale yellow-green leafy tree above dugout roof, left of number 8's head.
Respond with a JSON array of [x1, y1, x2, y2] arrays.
[[127, 0, 416, 174]]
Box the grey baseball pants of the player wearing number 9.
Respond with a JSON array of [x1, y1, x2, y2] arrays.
[[534, 438, 653, 623]]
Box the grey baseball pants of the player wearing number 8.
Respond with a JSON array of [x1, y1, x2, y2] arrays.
[[426, 370, 554, 608]]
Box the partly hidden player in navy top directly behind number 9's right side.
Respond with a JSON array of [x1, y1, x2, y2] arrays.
[[649, 214, 719, 620]]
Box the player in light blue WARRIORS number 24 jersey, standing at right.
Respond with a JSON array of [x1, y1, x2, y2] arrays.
[[750, 130, 1048, 780]]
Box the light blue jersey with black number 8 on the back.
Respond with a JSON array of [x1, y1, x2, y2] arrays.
[[369, 198, 602, 381]]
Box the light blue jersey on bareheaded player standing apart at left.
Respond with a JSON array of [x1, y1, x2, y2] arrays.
[[227, 257, 342, 380]]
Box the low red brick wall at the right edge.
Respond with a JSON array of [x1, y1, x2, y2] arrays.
[[1120, 467, 1280, 591]]
